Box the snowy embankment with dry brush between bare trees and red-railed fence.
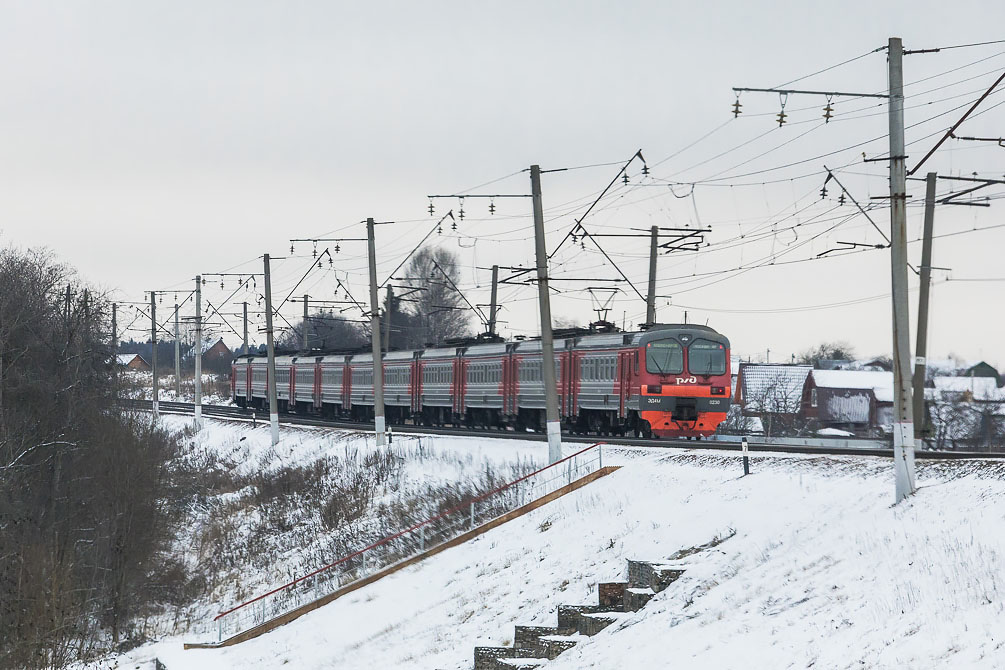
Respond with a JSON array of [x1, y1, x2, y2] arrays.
[[127, 414, 547, 636]]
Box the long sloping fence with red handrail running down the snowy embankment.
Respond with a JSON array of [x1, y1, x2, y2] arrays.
[[204, 443, 603, 642]]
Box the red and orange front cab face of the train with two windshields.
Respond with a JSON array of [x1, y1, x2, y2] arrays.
[[638, 324, 730, 439]]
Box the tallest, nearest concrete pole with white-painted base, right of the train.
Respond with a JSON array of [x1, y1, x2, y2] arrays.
[[887, 37, 915, 502]]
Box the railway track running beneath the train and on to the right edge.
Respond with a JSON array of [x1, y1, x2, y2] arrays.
[[119, 399, 1005, 460]]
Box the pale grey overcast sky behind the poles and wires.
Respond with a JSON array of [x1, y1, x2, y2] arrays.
[[0, 0, 1005, 365]]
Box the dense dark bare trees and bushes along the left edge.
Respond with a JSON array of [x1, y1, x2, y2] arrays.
[[0, 248, 186, 669]]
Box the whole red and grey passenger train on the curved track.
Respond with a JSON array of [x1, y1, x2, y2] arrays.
[[231, 323, 731, 438]]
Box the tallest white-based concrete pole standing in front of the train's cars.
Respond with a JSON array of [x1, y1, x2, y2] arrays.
[[531, 165, 562, 463]]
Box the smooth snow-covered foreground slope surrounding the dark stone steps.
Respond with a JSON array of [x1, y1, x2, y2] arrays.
[[92, 419, 1005, 670]]
